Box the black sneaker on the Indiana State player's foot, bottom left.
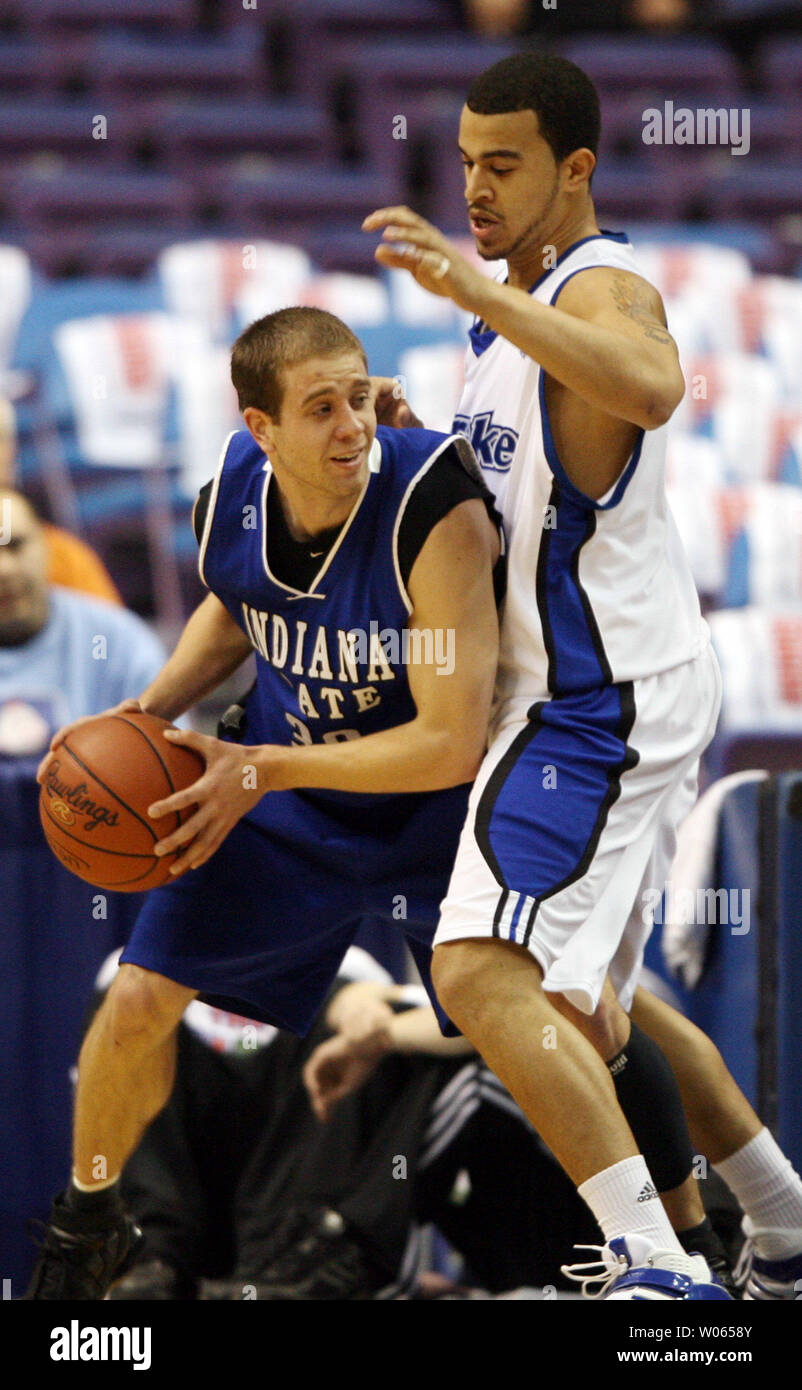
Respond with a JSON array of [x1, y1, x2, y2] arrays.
[[25, 1194, 143, 1301]]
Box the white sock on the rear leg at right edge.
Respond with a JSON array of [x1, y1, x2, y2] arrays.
[[713, 1127, 802, 1259]]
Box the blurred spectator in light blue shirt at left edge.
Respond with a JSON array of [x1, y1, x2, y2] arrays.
[[0, 487, 164, 753]]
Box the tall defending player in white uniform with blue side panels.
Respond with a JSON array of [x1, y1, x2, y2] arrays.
[[364, 53, 802, 1298]]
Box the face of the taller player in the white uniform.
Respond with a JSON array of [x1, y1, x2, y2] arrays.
[[459, 106, 560, 261]]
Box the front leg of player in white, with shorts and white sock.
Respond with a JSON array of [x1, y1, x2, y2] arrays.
[[436, 662, 733, 1297]]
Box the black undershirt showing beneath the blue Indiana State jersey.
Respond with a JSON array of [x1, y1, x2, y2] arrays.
[[193, 448, 503, 602]]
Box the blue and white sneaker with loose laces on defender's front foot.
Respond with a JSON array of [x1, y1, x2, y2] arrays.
[[562, 1234, 731, 1301]]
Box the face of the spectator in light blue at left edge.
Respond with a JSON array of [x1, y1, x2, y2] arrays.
[[0, 492, 47, 646]]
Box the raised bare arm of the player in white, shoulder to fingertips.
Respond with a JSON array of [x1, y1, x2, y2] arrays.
[[363, 207, 685, 430]]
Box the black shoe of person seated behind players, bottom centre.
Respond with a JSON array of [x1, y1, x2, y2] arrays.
[[202, 1208, 392, 1301]]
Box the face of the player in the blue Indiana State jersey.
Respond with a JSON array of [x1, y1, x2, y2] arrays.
[[265, 352, 377, 511]]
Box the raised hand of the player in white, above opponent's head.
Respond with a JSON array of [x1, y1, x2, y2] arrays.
[[361, 207, 485, 311]]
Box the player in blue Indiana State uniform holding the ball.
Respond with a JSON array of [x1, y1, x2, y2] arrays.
[[29, 309, 503, 1300]]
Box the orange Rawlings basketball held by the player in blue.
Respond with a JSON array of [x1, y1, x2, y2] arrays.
[[39, 710, 206, 892]]
